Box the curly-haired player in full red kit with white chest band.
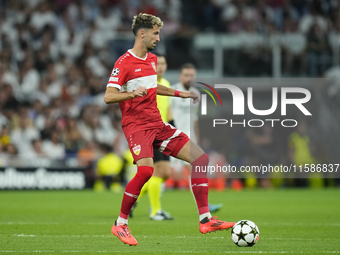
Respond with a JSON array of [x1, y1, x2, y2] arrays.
[[104, 13, 235, 245]]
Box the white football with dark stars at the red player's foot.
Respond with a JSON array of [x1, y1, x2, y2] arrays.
[[231, 220, 260, 247]]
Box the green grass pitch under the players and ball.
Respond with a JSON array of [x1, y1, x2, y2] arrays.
[[0, 189, 340, 254]]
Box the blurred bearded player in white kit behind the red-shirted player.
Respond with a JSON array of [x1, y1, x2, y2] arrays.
[[171, 63, 223, 212]]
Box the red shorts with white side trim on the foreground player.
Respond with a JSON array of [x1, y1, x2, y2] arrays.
[[126, 124, 190, 164]]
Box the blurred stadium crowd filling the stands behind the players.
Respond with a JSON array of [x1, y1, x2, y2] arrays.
[[0, 0, 340, 187]]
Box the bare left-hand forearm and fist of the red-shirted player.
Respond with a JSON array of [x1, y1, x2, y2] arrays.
[[104, 86, 147, 104]]
